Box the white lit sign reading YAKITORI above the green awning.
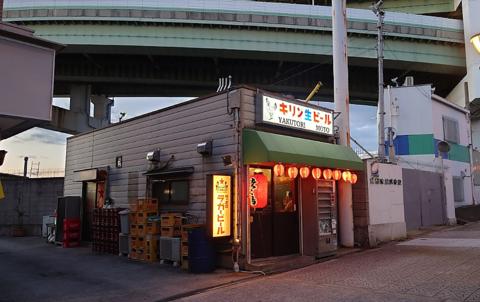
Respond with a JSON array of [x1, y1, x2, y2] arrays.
[[256, 94, 333, 136]]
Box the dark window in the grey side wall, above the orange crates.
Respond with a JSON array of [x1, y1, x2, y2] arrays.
[[152, 180, 189, 204]]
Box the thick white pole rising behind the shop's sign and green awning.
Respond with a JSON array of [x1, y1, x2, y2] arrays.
[[332, 0, 354, 247]]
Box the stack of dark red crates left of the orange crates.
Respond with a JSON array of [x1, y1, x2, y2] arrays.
[[92, 208, 122, 255]]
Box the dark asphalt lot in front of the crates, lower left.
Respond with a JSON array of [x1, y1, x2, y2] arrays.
[[0, 237, 252, 302]]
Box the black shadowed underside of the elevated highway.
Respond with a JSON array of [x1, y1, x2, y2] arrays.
[[55, 47, 463, 105]]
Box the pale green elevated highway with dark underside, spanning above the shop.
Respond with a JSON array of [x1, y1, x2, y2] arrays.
[[4, 0, 466, 104]]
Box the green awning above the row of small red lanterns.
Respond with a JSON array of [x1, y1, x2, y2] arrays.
[[243, 129, 363, 170]]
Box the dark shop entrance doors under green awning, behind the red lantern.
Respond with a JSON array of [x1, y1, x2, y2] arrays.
[[249, 168, 300, 259]]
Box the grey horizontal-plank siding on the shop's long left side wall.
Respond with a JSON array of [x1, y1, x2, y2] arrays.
[[64, 89, 254, 221]]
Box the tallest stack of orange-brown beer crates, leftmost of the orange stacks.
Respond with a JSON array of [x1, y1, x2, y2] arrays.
[[128, 199, 160, 262]]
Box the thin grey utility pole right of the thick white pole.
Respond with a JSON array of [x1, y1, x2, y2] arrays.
[[372, 0, 385, 162]]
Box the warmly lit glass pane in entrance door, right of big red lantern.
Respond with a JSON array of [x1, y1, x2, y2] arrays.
[[273, 176, 297, 212]]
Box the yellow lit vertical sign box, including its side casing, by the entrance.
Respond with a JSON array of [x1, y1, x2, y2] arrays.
[[207, 174, 232, 238]]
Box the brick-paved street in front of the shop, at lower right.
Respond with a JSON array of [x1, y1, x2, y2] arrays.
[[183, 223, 480, 302]]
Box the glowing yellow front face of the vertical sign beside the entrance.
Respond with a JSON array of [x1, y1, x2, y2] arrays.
[[211, 175, 232, 237]]
